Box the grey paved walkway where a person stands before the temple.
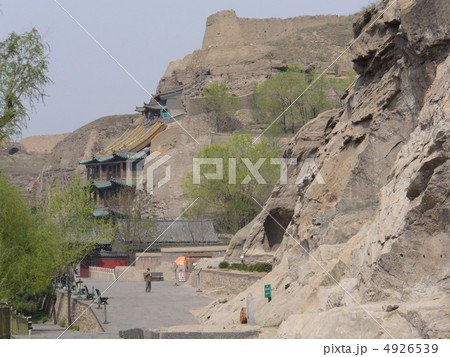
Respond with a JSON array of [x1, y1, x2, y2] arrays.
[[15, 278, 212, 338]]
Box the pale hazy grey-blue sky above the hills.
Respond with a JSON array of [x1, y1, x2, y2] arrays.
[[0, 0, 371, 140]]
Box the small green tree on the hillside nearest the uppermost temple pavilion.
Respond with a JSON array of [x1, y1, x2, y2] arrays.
[[202, 82, 240, 133]]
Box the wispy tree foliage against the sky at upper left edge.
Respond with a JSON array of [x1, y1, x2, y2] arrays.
[[0, 28, 51, 143]]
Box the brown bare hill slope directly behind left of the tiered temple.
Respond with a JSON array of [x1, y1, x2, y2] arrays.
[[31, 114, 140, 197]]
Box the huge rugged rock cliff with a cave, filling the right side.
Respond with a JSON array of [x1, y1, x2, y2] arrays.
[[201, 0, 450, 338]]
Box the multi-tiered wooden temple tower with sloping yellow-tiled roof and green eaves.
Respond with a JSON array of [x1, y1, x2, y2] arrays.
[[78, 120, 167, 217]]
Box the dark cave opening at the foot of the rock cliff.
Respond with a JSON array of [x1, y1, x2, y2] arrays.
[[263, 209, 294, 252]]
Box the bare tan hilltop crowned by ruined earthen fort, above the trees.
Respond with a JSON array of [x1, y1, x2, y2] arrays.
[[158, 10, 354, 98]]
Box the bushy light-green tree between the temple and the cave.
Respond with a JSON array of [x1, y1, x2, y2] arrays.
[[182, 134, 280, 233]]
